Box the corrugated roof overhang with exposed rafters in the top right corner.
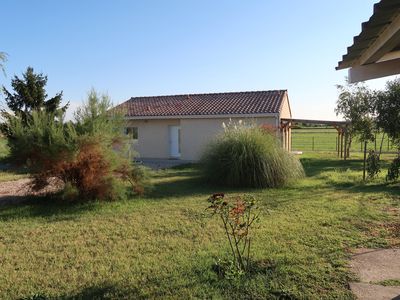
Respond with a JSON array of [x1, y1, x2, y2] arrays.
[[336, 0, 400, 83]]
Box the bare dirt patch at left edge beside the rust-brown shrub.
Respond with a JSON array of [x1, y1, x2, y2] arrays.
[[0, 178, 62, 205]]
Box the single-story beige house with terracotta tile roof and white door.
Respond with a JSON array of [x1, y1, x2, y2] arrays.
[[119, 90, 292, 161]]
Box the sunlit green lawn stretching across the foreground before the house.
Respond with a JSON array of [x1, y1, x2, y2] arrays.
[[0, 155, 400, 299]]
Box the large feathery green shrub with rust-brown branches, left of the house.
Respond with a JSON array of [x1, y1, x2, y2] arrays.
[[7, 91, 144, 200]]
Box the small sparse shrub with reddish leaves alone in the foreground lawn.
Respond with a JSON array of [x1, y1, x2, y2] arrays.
[[208, 193, 259, 277]]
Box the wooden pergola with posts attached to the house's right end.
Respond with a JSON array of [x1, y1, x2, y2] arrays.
[[281, 118, 351, 160]]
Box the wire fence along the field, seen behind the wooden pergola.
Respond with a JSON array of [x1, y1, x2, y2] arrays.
[[292, 128, 397, 152]]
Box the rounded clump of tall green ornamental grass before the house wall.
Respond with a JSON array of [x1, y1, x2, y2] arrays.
[[201, 122, 304, 188]]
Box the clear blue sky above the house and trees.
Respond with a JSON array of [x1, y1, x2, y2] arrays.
[[0, 0, 394, 119]]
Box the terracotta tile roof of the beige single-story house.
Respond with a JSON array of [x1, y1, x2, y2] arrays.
[[119, 90, 287, 117]]
